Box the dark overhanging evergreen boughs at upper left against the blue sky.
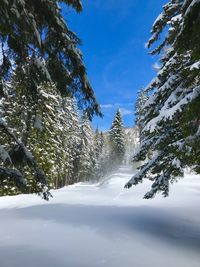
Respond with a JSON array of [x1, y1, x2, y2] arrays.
[[0, 0, 99, 116]]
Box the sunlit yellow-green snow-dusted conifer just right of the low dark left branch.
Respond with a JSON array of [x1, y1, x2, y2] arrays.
[[28, 83, 63, 192]]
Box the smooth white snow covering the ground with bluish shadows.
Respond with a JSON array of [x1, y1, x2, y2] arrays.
[[0, 167, 200, 267]]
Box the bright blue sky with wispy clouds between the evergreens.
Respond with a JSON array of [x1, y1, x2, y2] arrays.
[[63, 0, 167, 130]]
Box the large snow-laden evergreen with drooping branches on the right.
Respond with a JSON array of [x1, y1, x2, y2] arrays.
[[126, 0, 200, 198]]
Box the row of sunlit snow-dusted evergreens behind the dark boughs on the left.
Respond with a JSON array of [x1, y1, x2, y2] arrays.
[[0, 65, 125, 196]]
